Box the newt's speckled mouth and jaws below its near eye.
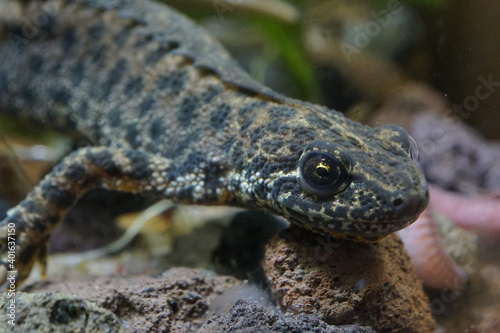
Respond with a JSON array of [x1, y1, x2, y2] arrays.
[[275, 174, 429, 240]]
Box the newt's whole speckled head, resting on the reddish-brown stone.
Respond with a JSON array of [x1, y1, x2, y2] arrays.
[[235, 102, 429, 240]]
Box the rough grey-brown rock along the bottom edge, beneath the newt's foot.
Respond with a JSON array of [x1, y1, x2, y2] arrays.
[[7, 268, 375, 333]]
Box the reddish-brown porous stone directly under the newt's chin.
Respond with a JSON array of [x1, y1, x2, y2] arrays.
[[263, 228, 435, 332]]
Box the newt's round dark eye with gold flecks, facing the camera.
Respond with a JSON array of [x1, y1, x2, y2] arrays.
[[298, 143, 351, 197]]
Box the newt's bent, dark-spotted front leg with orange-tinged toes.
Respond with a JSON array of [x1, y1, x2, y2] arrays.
[[0, 147, 188, 284]]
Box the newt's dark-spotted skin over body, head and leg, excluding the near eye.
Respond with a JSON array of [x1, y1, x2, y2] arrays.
[[0, 0, 428, 282]]
